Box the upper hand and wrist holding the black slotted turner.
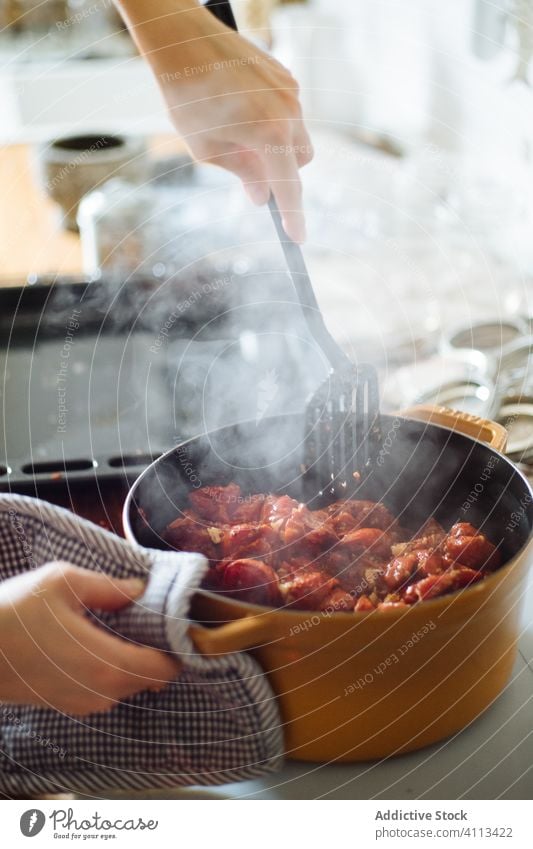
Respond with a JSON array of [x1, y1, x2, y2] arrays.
[[113, 0, 313, 242]]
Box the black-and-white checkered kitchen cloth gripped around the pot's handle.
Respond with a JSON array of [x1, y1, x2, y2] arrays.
[[0, 495, 283, 798]]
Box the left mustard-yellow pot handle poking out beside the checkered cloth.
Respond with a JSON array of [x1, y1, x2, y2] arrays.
[[188, 613, 273, 655]]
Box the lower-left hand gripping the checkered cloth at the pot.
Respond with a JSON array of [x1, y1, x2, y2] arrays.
[[0, 563, 179, 715]]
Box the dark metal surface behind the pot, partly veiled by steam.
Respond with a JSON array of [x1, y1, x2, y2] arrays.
[[0, 274, 321, 489]]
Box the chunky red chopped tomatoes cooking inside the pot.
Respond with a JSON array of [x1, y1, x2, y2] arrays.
[[164, 483, 501, 613]]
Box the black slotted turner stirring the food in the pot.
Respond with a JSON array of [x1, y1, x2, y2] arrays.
[[205, 0, 381, 497]]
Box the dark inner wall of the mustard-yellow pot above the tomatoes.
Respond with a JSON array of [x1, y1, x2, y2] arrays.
[[124, 415, 533, 561]]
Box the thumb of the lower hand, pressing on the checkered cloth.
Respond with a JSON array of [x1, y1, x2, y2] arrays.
[[63, 569, 146, 610]]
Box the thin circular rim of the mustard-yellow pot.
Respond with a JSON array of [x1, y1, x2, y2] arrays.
[[122, 413, 533, 622]]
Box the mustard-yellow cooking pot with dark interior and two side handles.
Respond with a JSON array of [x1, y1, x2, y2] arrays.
[[124, 407, 533, 761]]
